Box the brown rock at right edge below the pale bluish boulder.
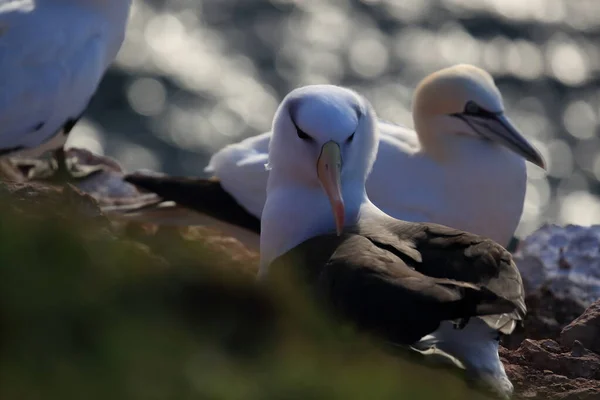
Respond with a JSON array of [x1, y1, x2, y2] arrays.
[[560, 300, 600, 354]]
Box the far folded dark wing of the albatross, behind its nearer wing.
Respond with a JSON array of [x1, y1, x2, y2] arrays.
[[360, 216, 527, 334]]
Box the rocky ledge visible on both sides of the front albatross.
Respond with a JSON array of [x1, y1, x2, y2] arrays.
[[0, 149, 600, 400]]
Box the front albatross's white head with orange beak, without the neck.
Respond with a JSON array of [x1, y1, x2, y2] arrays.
[[269, 85, 378, 234]]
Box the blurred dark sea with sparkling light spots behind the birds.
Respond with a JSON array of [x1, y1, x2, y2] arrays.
[[75, 0, 600, 236]]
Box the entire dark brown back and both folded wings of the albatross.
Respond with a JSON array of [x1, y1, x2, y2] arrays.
[[269, 212, 526, 345]]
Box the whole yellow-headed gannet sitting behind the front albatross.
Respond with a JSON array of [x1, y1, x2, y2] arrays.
[[127, 65, 545, 246]]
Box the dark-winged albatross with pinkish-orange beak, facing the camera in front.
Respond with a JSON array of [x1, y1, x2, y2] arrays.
[[259, 85, 526, 397]]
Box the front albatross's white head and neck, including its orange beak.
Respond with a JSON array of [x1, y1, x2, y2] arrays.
[[261, 85, 378, 274]]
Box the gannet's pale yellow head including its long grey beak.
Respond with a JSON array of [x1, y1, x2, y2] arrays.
[[413, 64, 546, 169]]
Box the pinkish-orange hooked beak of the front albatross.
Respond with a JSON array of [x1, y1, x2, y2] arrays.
[[317, 140, 345, 236]]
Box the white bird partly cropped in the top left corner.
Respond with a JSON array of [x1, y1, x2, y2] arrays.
[[0, 0, 131, 180]]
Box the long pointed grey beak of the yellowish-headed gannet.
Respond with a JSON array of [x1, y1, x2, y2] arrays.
[[452, 101, 546, 169]]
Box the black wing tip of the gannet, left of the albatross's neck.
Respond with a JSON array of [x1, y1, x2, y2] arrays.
[[125, 174, 260, 233]]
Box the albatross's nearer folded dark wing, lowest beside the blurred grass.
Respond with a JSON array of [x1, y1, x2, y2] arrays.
[[270, 234, 516, 345]]
